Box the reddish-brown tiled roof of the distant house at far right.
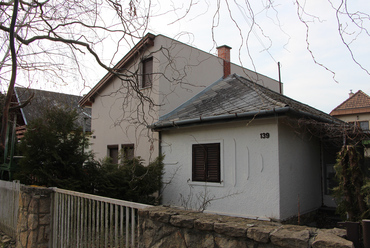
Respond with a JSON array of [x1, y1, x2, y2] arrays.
[[330, 90, 370, 116]]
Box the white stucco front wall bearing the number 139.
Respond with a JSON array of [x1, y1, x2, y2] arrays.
[[162, 119, 280, 219]]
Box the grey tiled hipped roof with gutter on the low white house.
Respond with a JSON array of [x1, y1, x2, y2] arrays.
[[150, 74, 341, 130]]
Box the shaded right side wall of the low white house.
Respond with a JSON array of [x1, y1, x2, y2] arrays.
[[279, 123, 322, 219]]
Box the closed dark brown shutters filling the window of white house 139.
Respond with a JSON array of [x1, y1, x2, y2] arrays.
[[192, 143, 221, 182]]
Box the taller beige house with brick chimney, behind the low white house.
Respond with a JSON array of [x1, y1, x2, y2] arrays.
[[80, 33, 282, 163]]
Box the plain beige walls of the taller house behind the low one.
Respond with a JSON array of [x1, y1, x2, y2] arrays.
[[92, 35, 279, 161]]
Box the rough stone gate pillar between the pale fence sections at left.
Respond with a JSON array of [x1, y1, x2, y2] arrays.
[[16, 186, 53, 248]]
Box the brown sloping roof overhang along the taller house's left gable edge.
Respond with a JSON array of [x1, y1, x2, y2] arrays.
[[80, 33, 156, 106]]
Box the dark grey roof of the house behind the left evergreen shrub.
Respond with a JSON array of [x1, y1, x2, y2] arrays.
[[14, 87, 91, 132]]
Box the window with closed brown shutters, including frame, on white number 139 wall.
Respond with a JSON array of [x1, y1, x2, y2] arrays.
[[191, 142, 223, 184]]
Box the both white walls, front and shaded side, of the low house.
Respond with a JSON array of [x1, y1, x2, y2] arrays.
[[162, 118, 322, 219]]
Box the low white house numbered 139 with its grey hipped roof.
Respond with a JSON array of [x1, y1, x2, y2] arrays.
[[150, 74, 343, 220]]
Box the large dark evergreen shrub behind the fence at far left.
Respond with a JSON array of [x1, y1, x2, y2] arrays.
[[16, 107, 89, 190]]
